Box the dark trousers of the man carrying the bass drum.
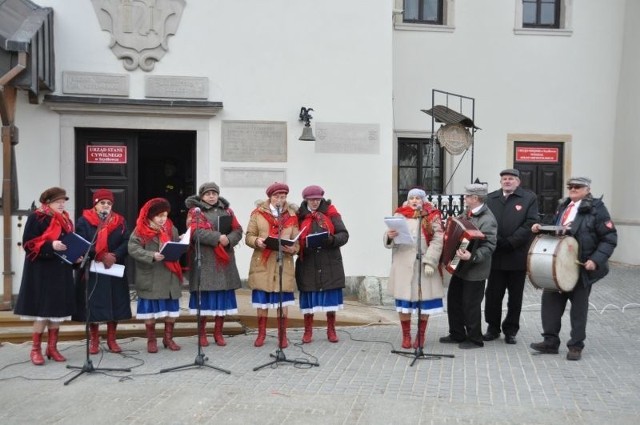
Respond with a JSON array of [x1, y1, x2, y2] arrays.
[[540, 281, 591, 349]]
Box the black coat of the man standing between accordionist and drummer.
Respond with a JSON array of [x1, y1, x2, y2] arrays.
[[487, 187, 538, 270]]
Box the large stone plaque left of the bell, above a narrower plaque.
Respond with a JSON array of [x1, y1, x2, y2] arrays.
[[222, 121, 287, 164]]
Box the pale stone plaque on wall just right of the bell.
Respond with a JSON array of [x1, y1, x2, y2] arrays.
[[314, 122, 380, 154]]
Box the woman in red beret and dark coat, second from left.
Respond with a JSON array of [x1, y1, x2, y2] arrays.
[[73, 189, 131, 354]]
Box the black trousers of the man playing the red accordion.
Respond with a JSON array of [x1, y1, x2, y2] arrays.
[[447, 275, 484, 345]]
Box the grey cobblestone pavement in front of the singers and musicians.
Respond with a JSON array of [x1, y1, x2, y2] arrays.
[[0, 266, 640, 425]]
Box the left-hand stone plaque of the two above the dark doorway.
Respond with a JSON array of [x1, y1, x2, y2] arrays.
[[62, 71, 129, 96]]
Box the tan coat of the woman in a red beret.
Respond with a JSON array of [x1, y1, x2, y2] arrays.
[[244, 201, 299, 292]]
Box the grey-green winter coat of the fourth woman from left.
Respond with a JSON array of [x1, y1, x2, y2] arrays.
[[184, 195, 242, 292]]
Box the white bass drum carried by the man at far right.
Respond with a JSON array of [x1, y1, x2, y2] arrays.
[[527, 235, 580, 292]]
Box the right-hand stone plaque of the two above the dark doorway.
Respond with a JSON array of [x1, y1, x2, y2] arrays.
[[144, 75, 209, 99]]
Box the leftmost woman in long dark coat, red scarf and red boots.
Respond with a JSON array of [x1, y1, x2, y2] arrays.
[[14, 187, 82, 365]]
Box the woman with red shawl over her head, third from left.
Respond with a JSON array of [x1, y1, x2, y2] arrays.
[[129, 198, 182, 353]]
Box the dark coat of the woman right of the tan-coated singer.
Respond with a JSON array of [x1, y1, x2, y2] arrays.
[[295, 199, 349, 292]]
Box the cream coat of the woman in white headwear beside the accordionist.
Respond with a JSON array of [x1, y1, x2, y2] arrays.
[[384, 214, 444, 301]]
